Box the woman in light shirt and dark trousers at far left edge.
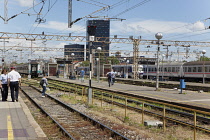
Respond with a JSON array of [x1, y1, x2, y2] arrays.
[[0, 69, 8, 101]]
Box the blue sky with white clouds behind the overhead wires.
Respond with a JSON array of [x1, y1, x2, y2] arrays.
[[0, 0, 210, 62]]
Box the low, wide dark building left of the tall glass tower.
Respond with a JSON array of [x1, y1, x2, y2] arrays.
[[64, 44, 84, 61]]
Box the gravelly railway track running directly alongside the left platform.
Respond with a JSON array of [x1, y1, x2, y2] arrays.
[[21, 86, 128, 140]]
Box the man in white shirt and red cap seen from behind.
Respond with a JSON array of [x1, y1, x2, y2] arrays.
[[7, 67, 21, 102]]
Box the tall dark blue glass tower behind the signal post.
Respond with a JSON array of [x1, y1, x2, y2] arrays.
[[86, 20, 110, 59]]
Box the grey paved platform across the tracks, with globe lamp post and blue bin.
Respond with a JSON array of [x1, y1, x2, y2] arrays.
[[49, 76, 210, 109]]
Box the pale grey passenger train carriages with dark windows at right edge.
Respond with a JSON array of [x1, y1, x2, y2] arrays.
[[143, 61, 210, 82]]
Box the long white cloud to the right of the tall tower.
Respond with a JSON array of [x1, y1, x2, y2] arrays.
[[111, 19, 205, 35]]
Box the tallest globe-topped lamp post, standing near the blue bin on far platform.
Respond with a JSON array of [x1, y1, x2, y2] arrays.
[[155, 33, 163, 90]]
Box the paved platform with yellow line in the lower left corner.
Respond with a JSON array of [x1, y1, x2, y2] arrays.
[[0, 93, 46, 140]]
